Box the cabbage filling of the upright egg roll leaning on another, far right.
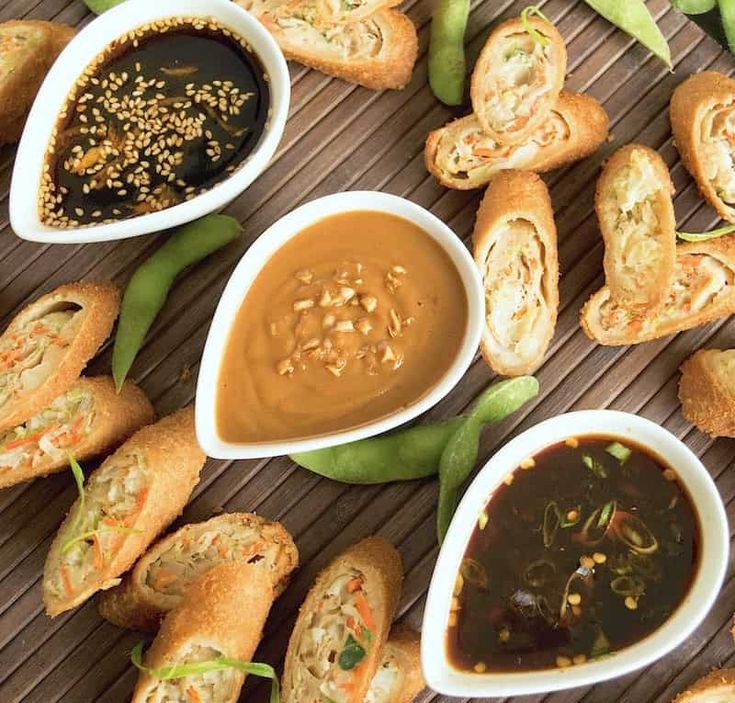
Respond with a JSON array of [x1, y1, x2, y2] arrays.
[[606, 150, 664, 291]]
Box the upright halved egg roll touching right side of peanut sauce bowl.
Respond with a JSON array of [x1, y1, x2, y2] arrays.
[[472, 171, 559, 376]]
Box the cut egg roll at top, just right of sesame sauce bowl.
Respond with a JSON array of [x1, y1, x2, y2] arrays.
[[257, 4, 418, 90]]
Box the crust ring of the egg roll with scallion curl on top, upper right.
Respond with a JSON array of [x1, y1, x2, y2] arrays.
[[470, 17, 567, 145]]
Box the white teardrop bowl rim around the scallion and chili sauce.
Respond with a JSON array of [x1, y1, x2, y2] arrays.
[[421, 410, 730, 697]]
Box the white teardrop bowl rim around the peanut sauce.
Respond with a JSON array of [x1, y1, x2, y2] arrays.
[[196, 191, 485, 459]]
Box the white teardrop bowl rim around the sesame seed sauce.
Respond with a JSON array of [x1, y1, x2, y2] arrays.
[[10, 0, 291, 244]]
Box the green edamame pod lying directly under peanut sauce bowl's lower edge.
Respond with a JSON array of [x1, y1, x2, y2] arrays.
[[291, 417, 463, 485]]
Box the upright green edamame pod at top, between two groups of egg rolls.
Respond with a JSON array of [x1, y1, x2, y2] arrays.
[[429, 0, 470, 105]]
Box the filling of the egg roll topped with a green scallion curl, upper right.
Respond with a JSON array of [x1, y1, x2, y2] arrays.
[[482, 32, 554, 133]]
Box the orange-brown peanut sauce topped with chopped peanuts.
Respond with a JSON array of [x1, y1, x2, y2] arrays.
[[216, 211, 468, 442]]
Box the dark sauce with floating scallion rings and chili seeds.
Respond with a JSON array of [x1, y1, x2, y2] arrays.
[[447, 437, 699, 672]]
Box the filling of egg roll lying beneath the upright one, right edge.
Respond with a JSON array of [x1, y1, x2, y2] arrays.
[[598, 254, 735, 335]]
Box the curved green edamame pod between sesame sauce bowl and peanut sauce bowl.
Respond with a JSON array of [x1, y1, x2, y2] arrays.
[[112, 215, 241, 392]]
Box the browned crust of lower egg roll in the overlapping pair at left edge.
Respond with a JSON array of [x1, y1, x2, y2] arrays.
[[0, 376, 155, 488]]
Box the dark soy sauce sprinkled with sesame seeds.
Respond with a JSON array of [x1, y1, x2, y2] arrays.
[[41, 18, 270, 227]]
